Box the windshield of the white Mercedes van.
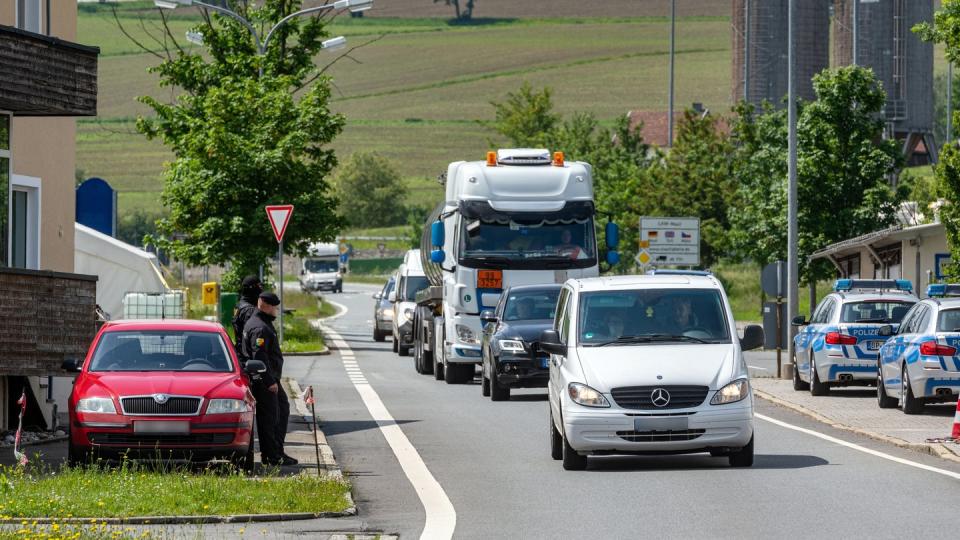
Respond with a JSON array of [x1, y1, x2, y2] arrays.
[[579, 289, 731, 346]]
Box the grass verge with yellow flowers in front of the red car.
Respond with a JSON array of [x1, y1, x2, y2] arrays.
[[0, 462, 350, 520]]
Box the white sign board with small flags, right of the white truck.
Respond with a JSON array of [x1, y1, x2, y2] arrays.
[[640, 216, 700, 266]]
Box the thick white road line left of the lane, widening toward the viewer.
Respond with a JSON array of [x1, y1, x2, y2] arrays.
[[322, 322, 457, 540]]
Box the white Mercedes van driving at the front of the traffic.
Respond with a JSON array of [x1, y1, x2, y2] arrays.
[[540, 274, 763, 470]]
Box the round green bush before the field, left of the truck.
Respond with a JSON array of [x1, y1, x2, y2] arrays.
[[334, 152, 407, 228]]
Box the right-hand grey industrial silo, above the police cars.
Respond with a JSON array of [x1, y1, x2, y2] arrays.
[[833, 0, 936, 164]]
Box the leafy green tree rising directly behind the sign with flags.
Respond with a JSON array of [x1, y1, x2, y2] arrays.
[[655, 110, 736, 266]]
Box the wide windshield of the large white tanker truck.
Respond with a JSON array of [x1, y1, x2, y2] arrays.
[[460, 218, 597, 268]]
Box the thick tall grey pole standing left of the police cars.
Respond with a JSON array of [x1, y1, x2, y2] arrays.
[[777, 0, 800, 377]]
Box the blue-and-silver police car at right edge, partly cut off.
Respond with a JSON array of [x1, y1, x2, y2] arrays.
[[877, 284, 960, 414]]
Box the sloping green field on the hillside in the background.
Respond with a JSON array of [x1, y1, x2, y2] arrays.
[[77, 0, 730, 217]]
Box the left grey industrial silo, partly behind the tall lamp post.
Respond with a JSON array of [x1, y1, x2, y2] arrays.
[[731, 0, 830, 107]]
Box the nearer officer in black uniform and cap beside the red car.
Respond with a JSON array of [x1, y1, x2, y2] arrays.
[[243, 292, 297, 465]]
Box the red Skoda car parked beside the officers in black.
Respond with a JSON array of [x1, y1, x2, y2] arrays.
[[63, 320, 266, 470]]
